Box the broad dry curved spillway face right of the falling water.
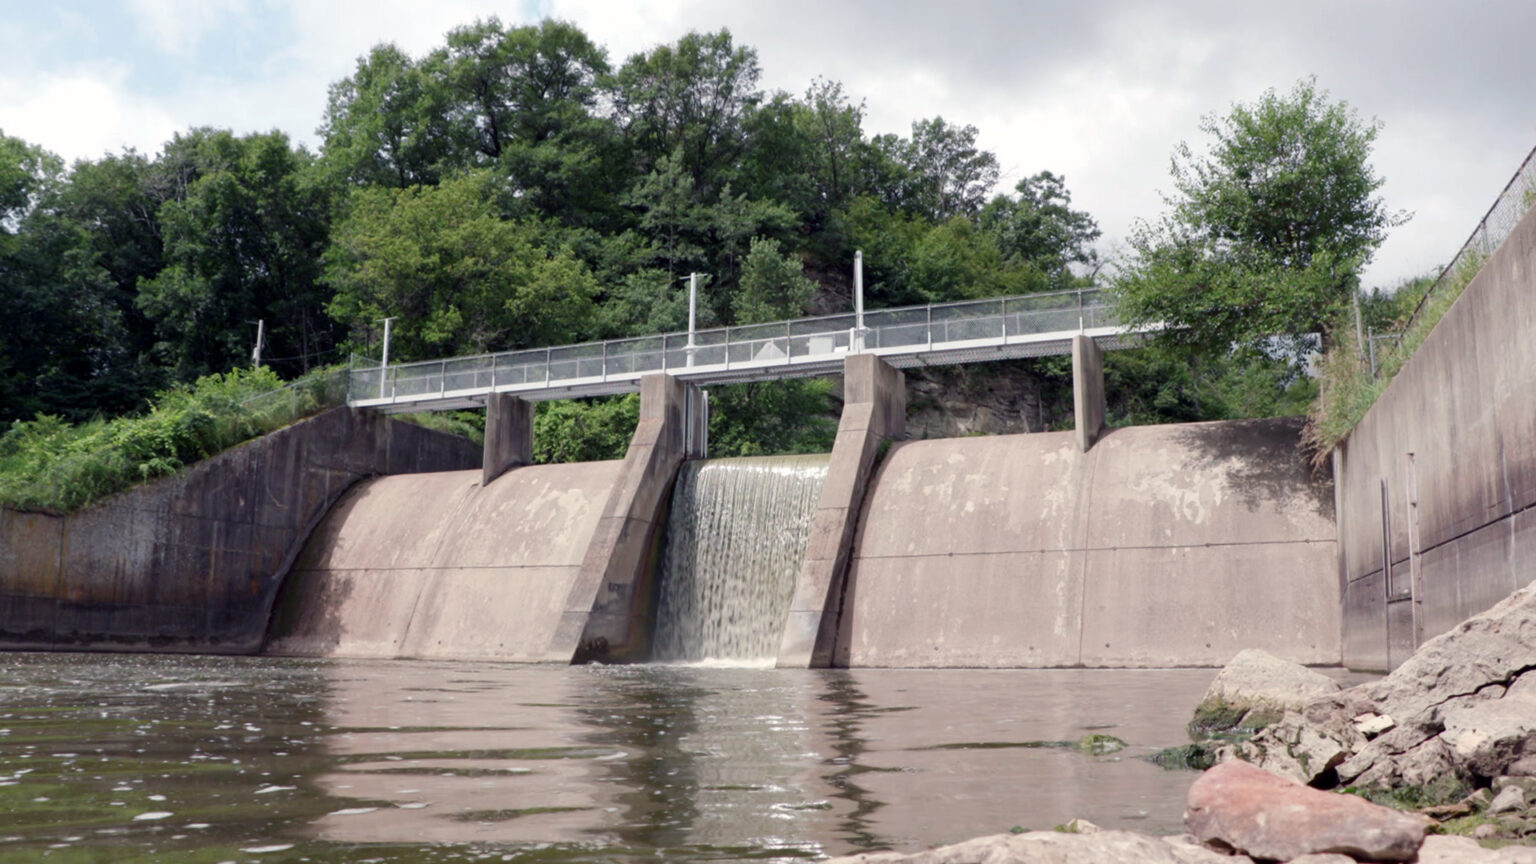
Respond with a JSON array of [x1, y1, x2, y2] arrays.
[[839, 420, 1339, 667]]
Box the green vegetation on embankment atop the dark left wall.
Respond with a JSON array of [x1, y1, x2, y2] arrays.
[[0, 367, 347, 512]]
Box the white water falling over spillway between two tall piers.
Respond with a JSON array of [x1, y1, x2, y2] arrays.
[[653, 454, 828, 663]]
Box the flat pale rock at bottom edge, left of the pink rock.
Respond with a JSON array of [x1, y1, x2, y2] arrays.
[[828, 830, 1250, 864]]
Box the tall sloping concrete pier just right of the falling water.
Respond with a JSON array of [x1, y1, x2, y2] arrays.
[[779, 355, 906, 669]]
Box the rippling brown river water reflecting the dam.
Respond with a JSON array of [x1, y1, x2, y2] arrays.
[[0, 655, 1212, 864]]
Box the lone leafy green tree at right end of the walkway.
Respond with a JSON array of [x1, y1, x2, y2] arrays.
[[1115, 80, 1407, 354]]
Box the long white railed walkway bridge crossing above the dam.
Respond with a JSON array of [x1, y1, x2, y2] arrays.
[[347, 289, 1150, 414]]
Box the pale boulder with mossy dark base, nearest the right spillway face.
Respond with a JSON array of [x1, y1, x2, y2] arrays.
[[1190, 649, 1339, 733]]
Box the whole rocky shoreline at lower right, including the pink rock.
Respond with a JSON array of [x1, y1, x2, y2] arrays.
[[833, 584, 1536, 864]]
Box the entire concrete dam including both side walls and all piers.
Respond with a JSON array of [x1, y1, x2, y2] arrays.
[[12, 186, 1536, 669]]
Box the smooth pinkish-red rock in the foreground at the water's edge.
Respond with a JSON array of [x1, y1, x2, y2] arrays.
[[1184, 761, 1425, 861]]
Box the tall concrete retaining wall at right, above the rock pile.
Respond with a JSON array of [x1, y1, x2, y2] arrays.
[[1335, 193, 1536, 670]]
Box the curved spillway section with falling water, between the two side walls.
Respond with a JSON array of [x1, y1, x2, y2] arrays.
[[248, 342, 1339, 667]]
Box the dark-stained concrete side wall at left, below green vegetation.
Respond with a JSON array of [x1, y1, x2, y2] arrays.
[[0, 409, 479, 653]]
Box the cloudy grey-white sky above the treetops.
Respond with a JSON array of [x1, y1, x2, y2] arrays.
[[0, 0, 1536, 286]]
